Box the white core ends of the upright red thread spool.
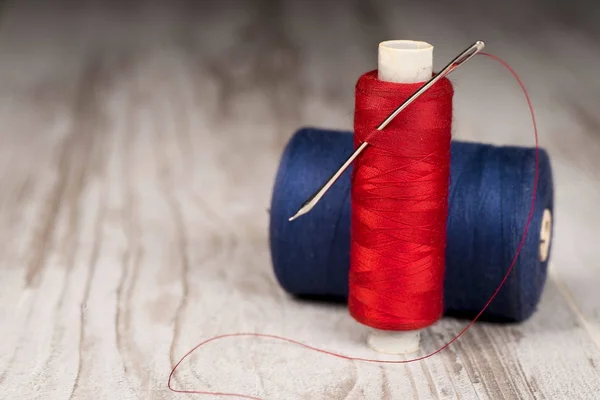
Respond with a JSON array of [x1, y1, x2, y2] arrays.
[[367, 40, 433, 354]]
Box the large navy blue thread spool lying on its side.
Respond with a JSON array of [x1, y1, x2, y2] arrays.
[[270, 129, 554, 322]]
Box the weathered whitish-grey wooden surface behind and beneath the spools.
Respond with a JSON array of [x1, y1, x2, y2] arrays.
[[0, 0, 600, 399]]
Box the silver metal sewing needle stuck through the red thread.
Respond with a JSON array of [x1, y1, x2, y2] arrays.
[[289, 41, 485, 221]]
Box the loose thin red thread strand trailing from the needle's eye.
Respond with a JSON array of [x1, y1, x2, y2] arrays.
[[167, 53, 539, 400]]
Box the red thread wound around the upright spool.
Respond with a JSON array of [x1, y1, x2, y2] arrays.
[[348, 71, 454, 331]]
